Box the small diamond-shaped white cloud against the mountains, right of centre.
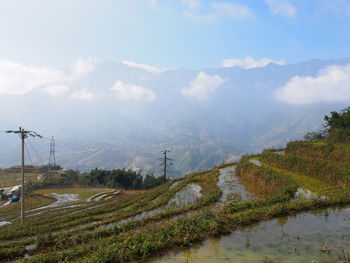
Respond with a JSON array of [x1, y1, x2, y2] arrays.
[[181, 72, 225, 100]]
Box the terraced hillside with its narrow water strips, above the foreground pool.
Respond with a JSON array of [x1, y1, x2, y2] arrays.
[[0, 141, 350, 262]]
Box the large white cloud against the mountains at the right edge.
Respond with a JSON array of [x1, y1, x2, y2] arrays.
[[275, 64, 350, 104]]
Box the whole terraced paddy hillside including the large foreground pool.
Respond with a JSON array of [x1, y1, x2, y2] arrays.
[[0, 142, 350, 263]]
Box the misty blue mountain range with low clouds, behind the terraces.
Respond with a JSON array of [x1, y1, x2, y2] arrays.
[[0, 58, 350, 176]]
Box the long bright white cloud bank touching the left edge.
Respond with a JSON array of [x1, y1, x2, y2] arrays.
[[0, 59, 93, 95]]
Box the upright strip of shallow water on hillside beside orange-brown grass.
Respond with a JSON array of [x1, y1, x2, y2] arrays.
[[217, 166, 254, 203]]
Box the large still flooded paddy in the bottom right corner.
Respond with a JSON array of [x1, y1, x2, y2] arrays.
[[151, 208, 350, 263]]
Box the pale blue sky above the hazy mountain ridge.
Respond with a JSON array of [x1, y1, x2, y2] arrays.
[[0, 0, 350, 69]]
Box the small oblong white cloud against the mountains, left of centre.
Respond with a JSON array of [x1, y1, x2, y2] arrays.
[[111, 80, 156, 102]]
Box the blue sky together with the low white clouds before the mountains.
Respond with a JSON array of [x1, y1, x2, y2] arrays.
[[0, 0, 350, 107]]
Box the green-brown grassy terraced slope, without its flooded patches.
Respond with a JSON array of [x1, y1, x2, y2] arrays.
[[0, 144, 350, 262]]
